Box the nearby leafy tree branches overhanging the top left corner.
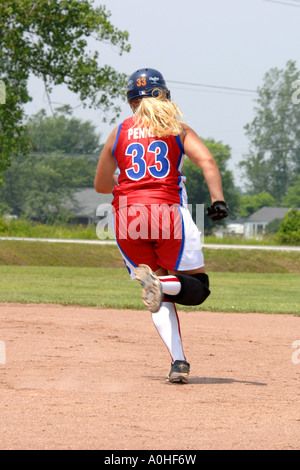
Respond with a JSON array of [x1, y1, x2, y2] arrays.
[[0, 0, 130, 176]]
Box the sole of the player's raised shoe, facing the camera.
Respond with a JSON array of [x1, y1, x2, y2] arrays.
[[134, 264, 163, 313]]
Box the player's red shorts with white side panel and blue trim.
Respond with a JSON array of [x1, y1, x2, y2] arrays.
[[113, 204, 204, 278]]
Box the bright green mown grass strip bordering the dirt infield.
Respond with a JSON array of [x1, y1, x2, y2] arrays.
[[0, 266, 300, 315]]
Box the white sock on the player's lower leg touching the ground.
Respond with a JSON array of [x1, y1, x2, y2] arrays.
[[152, 301, 186, 362]]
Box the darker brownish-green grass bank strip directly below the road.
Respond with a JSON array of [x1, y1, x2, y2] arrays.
[[0, 240, 300, 274]]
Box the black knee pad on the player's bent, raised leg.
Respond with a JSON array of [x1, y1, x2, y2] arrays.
[[165, 273, 210, 305]]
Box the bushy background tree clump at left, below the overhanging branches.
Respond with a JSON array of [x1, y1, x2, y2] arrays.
[[0, 107, 100, 222]]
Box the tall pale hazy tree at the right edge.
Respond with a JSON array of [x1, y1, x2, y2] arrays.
[[240, 61, 300, 204]]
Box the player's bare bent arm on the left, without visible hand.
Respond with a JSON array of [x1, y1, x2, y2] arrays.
[[94, 128, 118, 194]]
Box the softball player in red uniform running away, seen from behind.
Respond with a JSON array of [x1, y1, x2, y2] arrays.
[[95, 68, 228, 383]]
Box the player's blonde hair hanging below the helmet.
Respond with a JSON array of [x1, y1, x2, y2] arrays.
[[134, 88, 183, 137]]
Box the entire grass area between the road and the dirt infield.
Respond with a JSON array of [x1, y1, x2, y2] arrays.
[[0, 240, 300, 315]]
